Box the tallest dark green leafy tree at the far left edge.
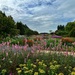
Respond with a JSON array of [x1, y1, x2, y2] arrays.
[[0, 11, 18, 37]]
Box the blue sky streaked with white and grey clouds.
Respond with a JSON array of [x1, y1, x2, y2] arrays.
[[0, 0, 75, 33]]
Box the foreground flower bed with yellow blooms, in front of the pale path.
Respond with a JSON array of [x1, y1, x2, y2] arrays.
[[0, 51, 75, 75]]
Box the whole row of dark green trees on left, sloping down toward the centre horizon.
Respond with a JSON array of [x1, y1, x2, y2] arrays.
[[0, 11, 38, 38]]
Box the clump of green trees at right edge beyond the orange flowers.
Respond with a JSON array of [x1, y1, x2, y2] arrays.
[[55, 21, 75, 37]]
